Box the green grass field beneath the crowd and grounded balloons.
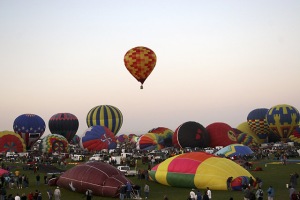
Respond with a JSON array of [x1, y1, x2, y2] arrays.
[[1, 158, 300, 200]]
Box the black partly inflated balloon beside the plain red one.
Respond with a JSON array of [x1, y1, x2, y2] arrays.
[[173, 121, 210, 148]]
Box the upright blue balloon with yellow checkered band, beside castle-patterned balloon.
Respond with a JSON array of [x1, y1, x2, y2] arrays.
[[247, 108, 271, 140]]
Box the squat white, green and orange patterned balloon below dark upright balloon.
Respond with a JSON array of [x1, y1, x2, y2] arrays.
[[39, 134, 69, 153]]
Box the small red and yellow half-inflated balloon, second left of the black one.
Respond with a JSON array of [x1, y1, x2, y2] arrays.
[[136, 133, 164, 150]]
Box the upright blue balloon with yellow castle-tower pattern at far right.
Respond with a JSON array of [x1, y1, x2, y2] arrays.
[[266, 104, 299, 141]]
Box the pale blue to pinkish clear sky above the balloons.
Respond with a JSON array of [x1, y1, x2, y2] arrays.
[[0, 0, 300, 138]]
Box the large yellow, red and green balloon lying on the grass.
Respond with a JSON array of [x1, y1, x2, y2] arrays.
[[149, 152, 252, 190]]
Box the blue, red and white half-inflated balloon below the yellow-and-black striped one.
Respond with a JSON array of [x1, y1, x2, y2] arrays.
[[80, 125, 117, 151]]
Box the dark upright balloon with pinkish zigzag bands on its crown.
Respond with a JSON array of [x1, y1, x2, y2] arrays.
[[49, 113, 79, 142]]
